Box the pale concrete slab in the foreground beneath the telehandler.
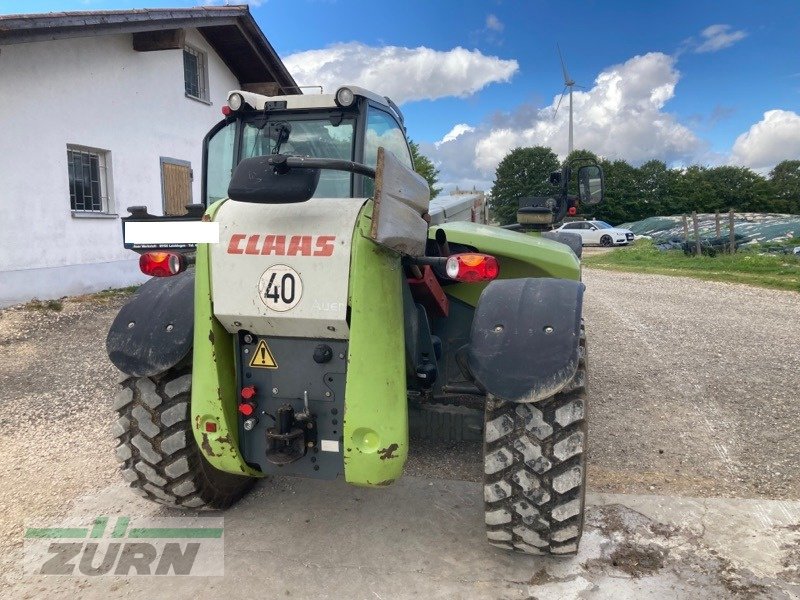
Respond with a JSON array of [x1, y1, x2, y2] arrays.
[[10, 478, 800, 600]]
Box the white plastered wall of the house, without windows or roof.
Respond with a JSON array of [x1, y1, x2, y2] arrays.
[[0, 30, 239, 306]]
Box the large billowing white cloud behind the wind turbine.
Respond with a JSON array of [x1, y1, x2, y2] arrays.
[[422, 53, 705, 191]]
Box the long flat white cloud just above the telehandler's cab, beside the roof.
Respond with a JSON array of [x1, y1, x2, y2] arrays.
[[284, 42, 519, 103]]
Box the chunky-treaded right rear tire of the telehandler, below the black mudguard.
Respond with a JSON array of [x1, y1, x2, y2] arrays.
[[483, 325, 588, 555]]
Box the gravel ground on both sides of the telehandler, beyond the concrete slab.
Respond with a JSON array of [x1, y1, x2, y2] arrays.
[[0, 269, 800, 571]]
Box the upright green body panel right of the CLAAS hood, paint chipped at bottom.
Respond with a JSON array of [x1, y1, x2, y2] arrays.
[[344, 201, 408, 486]]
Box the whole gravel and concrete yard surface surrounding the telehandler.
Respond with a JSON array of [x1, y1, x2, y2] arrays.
[[0, 269, 800, 600]]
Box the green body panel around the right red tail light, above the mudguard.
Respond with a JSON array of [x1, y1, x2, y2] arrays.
[[428, 221, 581, 306]]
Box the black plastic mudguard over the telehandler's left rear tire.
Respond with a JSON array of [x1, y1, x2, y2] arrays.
[[106, 269, 194, 377]]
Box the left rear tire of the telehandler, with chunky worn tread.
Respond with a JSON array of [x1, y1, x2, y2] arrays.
[[112, 366, 255, 509]]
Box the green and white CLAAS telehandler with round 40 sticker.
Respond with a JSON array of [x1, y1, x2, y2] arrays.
[[107, 86, 602, 555]]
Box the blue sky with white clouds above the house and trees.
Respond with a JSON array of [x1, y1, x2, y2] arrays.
[[0, 0, 800, 191]]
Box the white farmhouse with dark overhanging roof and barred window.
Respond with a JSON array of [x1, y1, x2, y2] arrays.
[[0, 6, 300, 306]]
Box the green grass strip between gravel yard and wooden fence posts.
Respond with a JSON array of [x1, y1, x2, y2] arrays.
[[583, 240, 800, 292]]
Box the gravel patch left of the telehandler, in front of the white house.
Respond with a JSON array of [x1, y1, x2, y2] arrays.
[[0, 297, 123, 572]]
